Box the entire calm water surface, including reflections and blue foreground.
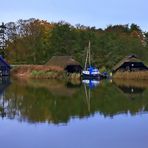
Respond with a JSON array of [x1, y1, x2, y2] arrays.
[[0, 80, 148, 148]]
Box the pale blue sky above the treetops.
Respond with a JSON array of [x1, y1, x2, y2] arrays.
[[0, 0, 148, 31]]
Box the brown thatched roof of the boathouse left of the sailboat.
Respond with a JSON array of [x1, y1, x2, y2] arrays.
[[46, 56, 80, 69]]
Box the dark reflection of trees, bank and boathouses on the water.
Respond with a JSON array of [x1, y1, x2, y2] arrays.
[[0, 80, 148, 124]]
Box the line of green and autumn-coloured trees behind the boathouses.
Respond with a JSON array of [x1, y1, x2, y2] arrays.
[[5, 19, 148, 69]]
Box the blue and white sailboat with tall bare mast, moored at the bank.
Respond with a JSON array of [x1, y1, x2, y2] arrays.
[[82, 41, 100, 79]]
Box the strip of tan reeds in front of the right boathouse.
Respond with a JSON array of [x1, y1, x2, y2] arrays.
[[113, 71, 148, 80]]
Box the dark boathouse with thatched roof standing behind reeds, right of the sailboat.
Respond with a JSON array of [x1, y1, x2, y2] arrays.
[[113, 55, 148, 72]]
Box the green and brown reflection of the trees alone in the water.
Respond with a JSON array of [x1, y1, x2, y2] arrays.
[[4, 81, 148, 124]]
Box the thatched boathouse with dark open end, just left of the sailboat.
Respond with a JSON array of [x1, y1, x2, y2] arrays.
[[46, 56, 82, 73]]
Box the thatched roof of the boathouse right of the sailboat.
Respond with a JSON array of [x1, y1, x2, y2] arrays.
[[113, 55, 142, 71]]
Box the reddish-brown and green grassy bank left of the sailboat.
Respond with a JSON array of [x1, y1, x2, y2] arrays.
[[11, 65, 80, 80]]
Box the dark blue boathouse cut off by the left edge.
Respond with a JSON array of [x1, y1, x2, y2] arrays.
[[0, 55, 11, 77]]
